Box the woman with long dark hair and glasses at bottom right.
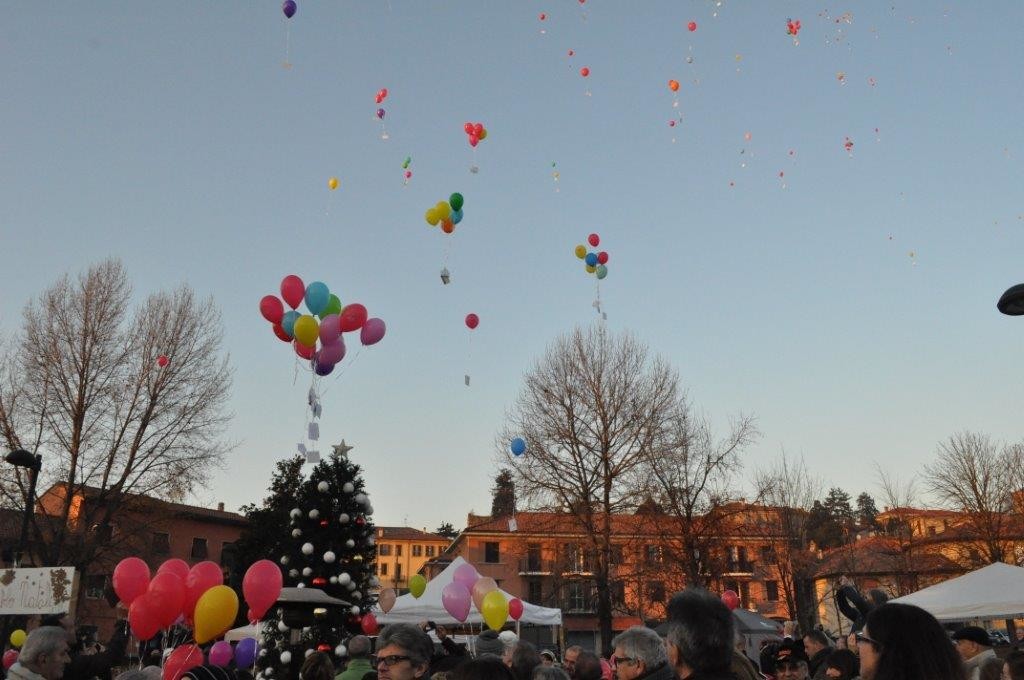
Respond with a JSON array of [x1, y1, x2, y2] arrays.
[[857, 602, 967, 680]]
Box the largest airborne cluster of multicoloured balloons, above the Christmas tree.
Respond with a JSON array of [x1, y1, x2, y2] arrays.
[[259, 274, 386, 376]]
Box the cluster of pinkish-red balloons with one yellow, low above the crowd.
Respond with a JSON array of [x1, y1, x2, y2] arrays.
[[113, 557, 283, 647]]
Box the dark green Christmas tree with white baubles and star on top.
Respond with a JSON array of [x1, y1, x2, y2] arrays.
[[244, 441, 379, 680]]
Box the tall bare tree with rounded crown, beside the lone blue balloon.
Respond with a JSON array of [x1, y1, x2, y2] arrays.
[[498, 326, 680, 652]]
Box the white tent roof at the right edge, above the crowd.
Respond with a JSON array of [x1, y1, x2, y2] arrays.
[[892, 562, 1024, 621]]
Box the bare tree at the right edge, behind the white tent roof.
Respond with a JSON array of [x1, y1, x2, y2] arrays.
[[925, 431, 1024, 566]]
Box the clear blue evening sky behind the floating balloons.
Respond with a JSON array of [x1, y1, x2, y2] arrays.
[[0, 0, 1024, 529]]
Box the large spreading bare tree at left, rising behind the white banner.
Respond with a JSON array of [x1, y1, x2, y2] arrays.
[[0, 260, 231, 568]]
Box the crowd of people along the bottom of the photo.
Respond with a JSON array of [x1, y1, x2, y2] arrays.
[[7, 589, 1024, 680]]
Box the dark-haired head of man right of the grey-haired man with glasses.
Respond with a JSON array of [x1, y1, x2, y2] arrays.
[[665, 588, 734, 677]]
